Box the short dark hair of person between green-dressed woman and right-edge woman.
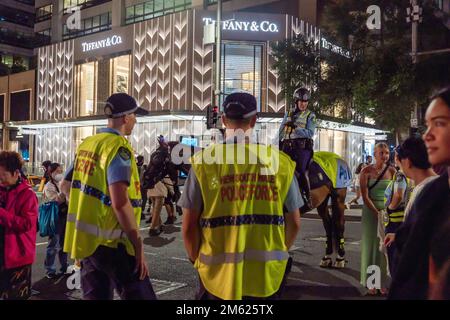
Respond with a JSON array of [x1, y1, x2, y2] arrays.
[[395, 137, 431, 170]]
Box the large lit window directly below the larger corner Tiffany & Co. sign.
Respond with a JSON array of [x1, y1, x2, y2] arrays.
[[221, 43, 263, 111]]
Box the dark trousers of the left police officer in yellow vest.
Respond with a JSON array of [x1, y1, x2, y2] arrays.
[[81, 244, 156, 300]]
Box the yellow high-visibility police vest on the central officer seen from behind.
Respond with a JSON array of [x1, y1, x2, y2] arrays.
[[191, 143, 295, 299]]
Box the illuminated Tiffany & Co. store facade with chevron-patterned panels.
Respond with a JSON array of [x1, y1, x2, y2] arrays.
[[9, 1, 381, 174]]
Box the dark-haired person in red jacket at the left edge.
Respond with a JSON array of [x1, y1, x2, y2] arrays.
[[0, 151, 38, 300]]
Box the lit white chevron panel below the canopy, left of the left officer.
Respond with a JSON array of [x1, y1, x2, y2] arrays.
[[35, 127, 76, 168]]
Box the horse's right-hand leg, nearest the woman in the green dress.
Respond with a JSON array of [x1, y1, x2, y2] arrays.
[[331, 189, 347, 268]]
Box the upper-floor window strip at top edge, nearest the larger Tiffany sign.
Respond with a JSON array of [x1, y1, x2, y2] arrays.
[[125, 0, 192, 24]]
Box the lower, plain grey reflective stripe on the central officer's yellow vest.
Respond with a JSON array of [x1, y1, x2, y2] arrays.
[[199, 249, 289, 265]]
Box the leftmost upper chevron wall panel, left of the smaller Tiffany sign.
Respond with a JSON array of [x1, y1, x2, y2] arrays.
[[36, 40, 74, 120]]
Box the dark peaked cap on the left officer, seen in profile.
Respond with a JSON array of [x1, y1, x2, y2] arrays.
[[104, 93, 149, 118]]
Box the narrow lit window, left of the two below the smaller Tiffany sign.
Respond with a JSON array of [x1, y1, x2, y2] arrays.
[[76, 62, 97, 116]]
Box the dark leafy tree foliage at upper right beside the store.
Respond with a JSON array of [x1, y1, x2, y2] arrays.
[[273, 0, 450, 136]]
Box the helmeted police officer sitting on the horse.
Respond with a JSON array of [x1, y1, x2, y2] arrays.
[[279, 87, 316, 212]]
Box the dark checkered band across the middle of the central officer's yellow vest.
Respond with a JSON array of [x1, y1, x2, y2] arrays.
[[200, 214, 284, 228]]
